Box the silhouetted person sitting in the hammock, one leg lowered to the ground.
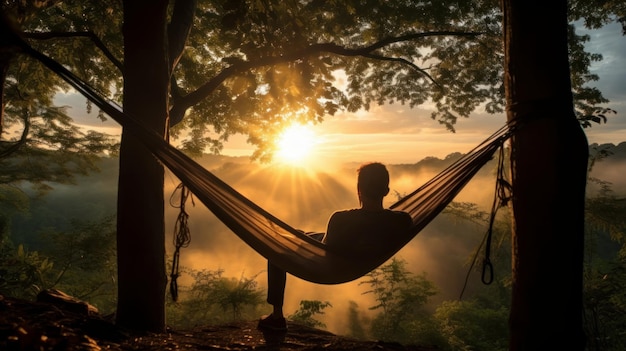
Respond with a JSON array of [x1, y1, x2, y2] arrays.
[[258, 162, 413, 331]]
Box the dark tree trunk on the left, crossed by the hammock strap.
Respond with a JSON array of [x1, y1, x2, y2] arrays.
[[117, 0, 168, 332]]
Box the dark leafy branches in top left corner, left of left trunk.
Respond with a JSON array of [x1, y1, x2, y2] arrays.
[[2, 0, 123, 108]]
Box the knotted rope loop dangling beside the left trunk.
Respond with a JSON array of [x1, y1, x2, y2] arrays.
[[170, 183, 195, 302]]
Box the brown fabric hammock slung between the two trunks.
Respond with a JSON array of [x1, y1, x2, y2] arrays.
[[14, 31, 512, 284]]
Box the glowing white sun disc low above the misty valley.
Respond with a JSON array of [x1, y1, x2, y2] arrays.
[[276, 124, 316, 165]]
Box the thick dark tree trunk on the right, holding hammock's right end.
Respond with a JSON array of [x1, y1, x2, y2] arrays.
[[502, 0, 588, 350]]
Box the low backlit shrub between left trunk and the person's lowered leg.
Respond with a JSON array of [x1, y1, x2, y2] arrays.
[[167, 269, 265, 328]]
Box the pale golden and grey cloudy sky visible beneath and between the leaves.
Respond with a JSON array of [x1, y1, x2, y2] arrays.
[[57, 24, 626, 167]]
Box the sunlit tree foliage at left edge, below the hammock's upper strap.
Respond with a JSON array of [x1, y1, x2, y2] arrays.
[[0, 46, 118, 192]]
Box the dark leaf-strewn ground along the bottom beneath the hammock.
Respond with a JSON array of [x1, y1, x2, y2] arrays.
[[0, 295, 436, 351]]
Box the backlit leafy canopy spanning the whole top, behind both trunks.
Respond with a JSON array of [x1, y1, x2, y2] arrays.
[[5, 0, 623, 159]]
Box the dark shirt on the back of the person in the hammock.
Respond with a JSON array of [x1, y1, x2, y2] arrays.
[[322, 209, 413, 253]]
